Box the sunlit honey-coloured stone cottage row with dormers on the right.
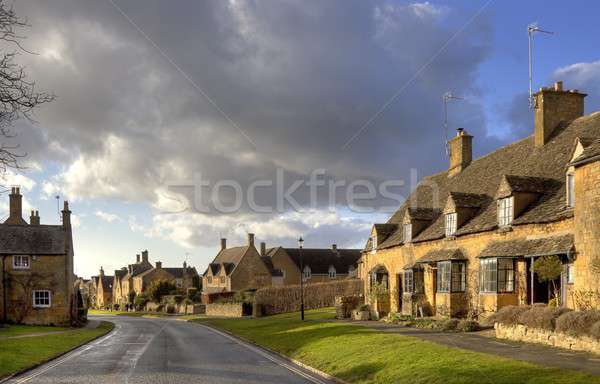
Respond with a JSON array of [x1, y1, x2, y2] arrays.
[[359, 82, 600, 316]]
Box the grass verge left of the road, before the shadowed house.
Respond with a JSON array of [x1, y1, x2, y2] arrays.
[[0, 321, 113, 378]]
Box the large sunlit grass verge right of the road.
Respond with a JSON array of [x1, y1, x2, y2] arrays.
[[195, 311, 600, 384]]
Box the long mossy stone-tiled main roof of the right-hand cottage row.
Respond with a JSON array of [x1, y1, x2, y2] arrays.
[[378, 113, 600, 248]]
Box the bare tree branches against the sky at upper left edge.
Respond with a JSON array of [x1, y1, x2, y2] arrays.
[[0, 0, 55, 174]]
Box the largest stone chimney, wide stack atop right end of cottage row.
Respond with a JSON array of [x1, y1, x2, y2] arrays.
[[534, 81, 587, 148]]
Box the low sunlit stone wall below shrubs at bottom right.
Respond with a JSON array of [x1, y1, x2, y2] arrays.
[[494, 323, 600, 354]]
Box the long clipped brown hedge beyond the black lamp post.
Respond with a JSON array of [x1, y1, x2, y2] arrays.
[[254, 279, 363, 315]]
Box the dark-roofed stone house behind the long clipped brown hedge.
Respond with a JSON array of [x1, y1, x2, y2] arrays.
[[261, 243, 361, 285]]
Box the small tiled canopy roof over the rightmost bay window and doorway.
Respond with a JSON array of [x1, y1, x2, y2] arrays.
[[478, 235, 574, 258]]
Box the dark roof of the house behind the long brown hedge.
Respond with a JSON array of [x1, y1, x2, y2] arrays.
[[281, 248, 361, 274]]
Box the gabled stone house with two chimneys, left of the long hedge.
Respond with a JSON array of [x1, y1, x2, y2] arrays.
[[202, 233, 280, 294]]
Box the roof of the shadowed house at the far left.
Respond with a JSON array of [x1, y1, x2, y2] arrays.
[[0, 224, 66, 255]]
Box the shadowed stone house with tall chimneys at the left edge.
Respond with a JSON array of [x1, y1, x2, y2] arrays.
[[0, 187, 77, 325]]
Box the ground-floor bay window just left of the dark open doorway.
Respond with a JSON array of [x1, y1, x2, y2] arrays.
[[479, 258, 515, 293]]
